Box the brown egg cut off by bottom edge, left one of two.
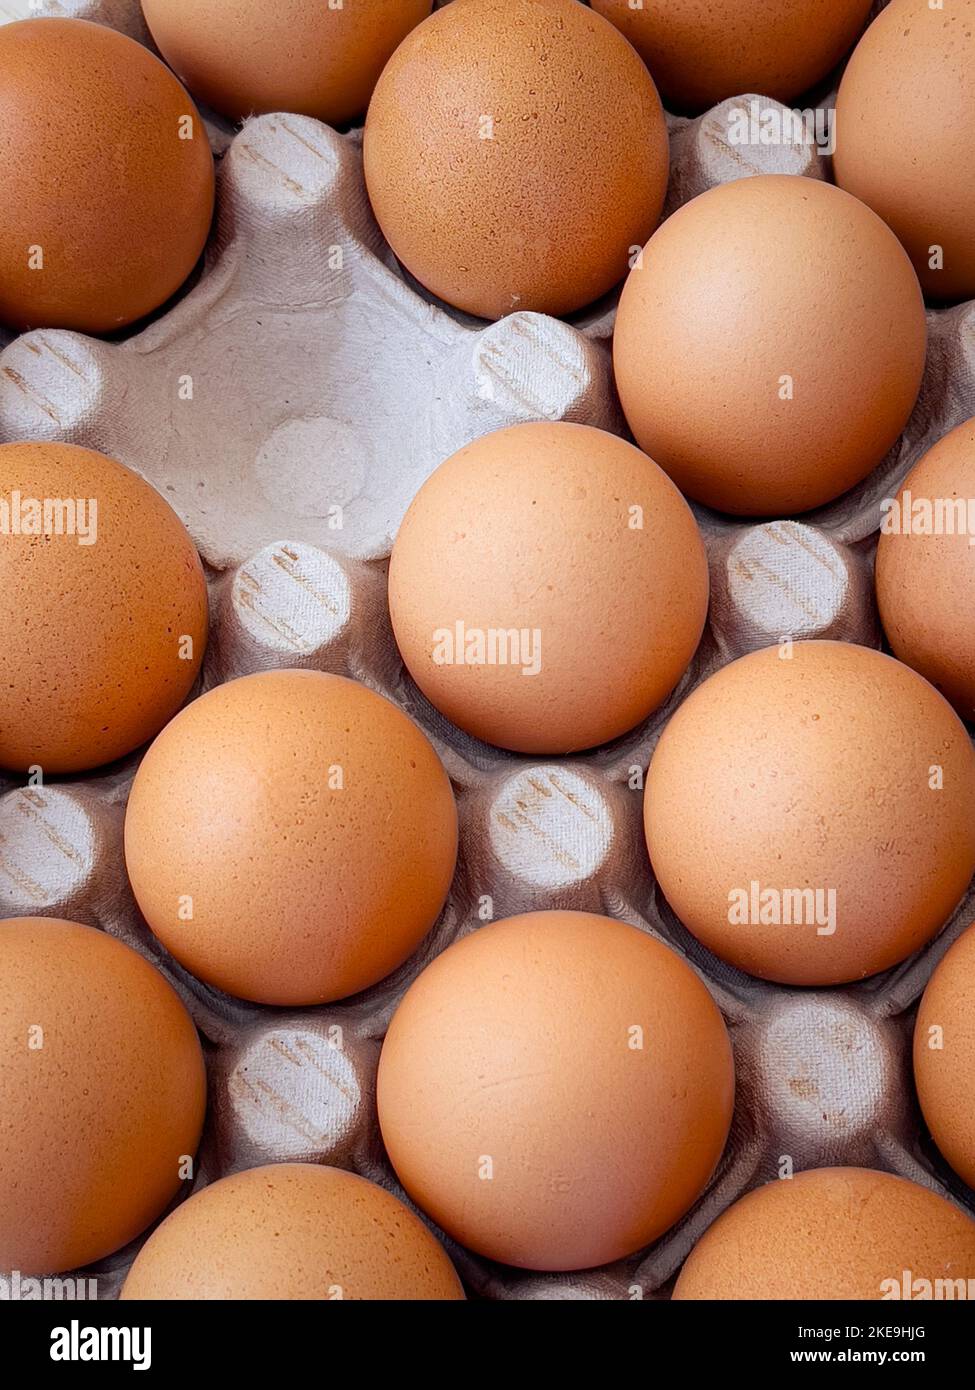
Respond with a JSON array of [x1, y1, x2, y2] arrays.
[[120, 1163, 463, 1301]]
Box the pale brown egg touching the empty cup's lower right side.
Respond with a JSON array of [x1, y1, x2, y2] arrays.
[[389, 424, 708, 753]]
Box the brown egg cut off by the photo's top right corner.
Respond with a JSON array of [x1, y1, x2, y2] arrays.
[[833, 0, 975, 299]]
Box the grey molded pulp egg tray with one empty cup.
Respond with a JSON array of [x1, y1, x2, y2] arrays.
[[0, 0, 975, 1298]]
